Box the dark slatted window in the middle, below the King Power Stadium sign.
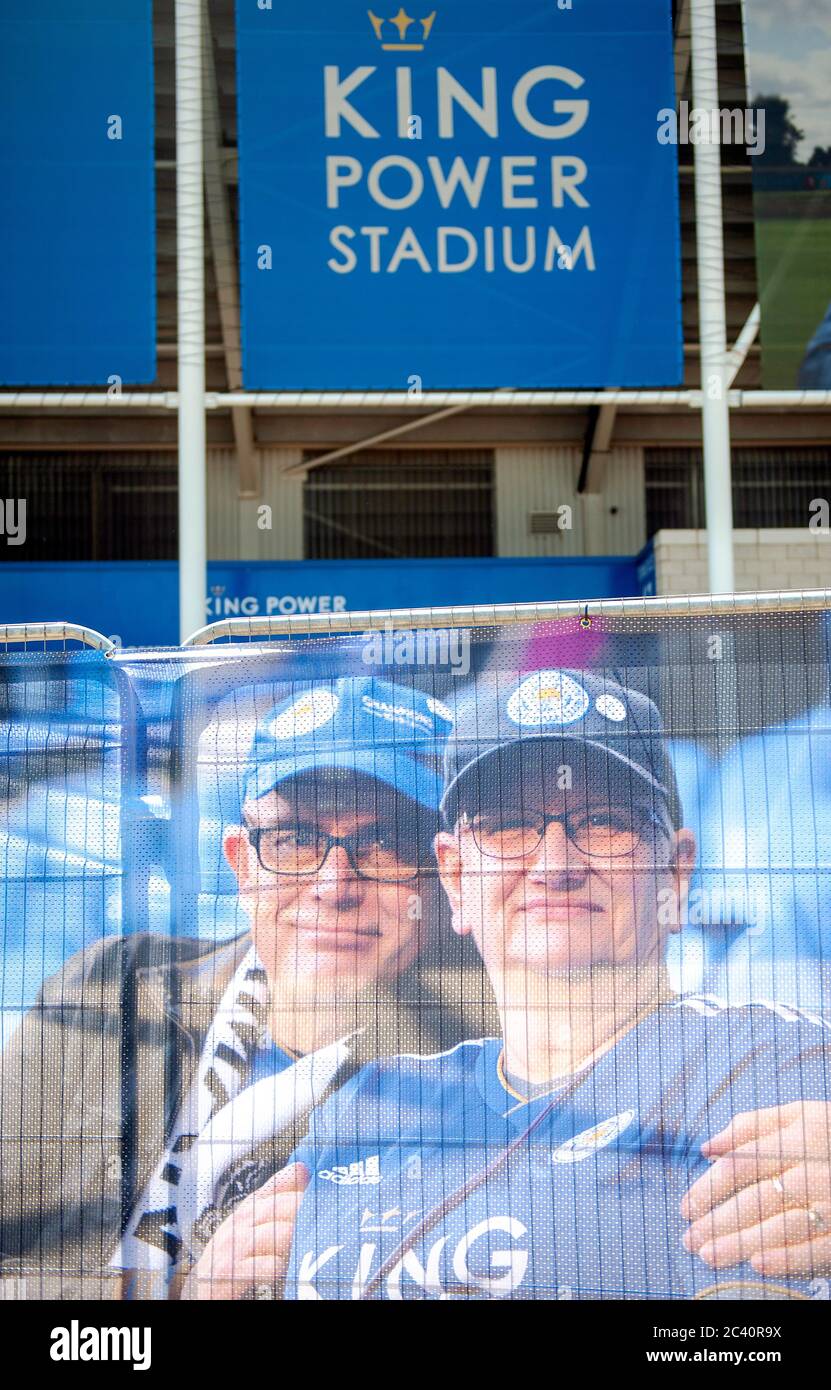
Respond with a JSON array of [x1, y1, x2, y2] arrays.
[[303, 449, 495, 560]]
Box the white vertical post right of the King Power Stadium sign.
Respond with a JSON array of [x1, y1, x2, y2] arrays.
[[691, 0, 735, 594]]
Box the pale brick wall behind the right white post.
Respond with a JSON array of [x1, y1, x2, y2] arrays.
[[655, 527, 831, 594]]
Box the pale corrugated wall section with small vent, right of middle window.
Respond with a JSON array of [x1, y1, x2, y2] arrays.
[[496, 446, 646, 556]]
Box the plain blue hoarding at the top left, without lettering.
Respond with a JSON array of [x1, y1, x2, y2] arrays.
[[0, 0, 156, 388]]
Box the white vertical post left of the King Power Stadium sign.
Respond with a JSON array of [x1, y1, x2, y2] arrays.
[[176, 0, 207, 638]]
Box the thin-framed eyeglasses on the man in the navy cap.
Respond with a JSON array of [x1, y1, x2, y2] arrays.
[[463, 806, 668, 859]]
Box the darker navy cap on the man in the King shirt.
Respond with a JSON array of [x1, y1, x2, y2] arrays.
[[441, 670, 682, 828]]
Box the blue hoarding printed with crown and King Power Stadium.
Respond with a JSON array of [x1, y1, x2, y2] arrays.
[[236, 0, 682, 391]]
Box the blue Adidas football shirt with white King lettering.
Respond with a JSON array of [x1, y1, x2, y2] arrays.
[[285, 995, 831, 1300]]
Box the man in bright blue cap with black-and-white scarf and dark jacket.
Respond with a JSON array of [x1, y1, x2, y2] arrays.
[[0, 677, 459, 1297]]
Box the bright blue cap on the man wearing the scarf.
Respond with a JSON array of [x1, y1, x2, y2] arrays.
[[245, 677, 452, 810]]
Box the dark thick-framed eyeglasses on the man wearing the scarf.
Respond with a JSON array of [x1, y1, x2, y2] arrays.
[[247, 820, 420, 883]]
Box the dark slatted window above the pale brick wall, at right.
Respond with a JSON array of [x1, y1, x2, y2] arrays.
[[645, 448, 831, 535]]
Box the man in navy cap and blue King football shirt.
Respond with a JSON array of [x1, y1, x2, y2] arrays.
[[209, 670, 831, 1300]]
